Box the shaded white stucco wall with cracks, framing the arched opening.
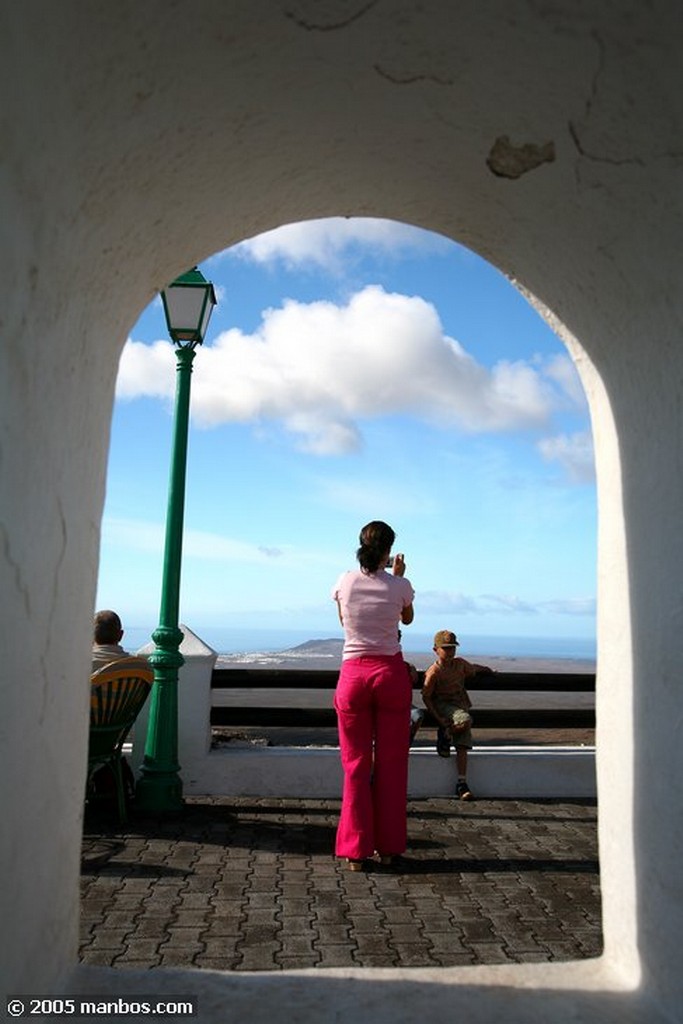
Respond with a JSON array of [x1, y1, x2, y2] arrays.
[[0, 0, 683, 1024]]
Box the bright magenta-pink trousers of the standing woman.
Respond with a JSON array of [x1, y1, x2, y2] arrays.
[[335, 654, 412, 860]]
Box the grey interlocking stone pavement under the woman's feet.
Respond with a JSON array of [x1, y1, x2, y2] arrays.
[[80, 798, 602, 971]]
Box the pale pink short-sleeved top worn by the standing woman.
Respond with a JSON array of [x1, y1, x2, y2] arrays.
[[332, 569, 415, 658]]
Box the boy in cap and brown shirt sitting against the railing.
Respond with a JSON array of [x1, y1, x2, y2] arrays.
[[422, 630, 492, 800]]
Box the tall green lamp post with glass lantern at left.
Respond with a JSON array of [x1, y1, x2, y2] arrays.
[[135, 267, 216, 813]]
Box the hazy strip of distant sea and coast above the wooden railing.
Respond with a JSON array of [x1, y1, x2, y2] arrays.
[[123, 626, 596, 671]]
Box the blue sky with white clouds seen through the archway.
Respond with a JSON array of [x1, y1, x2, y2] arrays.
[[97, 218, 596, 645]]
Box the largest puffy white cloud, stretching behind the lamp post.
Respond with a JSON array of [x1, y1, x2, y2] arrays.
[[118, 285, 556, 455]]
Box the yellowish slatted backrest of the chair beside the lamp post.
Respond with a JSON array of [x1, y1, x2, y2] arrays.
[[89, 656, 154, 759]]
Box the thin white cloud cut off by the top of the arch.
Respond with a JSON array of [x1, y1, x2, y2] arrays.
[[226, 217, 452, 271]]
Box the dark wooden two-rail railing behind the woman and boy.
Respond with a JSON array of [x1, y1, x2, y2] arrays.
[[211, 669, 595, 729]]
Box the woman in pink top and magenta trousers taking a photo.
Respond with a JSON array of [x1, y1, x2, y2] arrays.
[[332, 521, 415, 870]]
